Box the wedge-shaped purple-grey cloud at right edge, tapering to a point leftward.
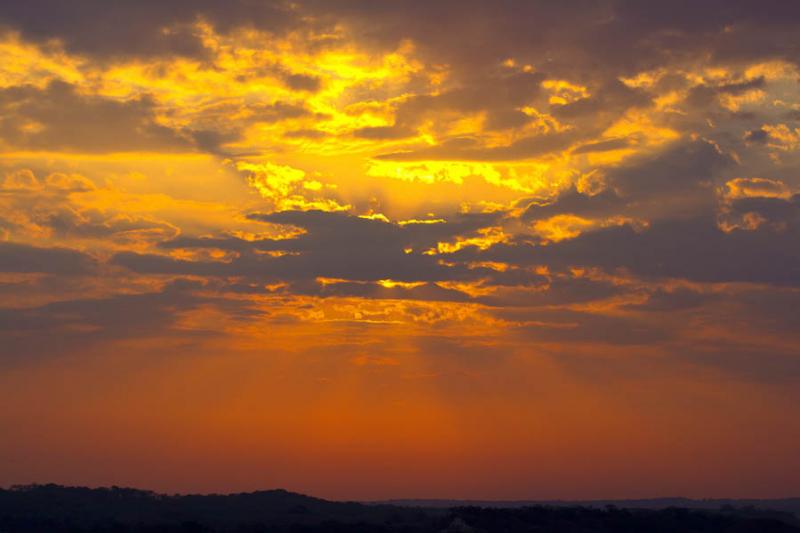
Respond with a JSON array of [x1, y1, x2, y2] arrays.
[[453, 216, 800, 285]]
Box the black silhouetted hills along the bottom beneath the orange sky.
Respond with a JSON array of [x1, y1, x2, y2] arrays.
[[0, 485, 800, 533]]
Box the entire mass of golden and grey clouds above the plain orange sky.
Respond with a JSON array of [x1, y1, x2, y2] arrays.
[[0, 0, 800, 394]]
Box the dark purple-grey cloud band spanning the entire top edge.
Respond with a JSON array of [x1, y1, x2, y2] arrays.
[[0, 0, 800, 76]]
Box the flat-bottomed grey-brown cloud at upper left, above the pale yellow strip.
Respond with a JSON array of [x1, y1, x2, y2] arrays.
[[0, 81, 316, 155]]
